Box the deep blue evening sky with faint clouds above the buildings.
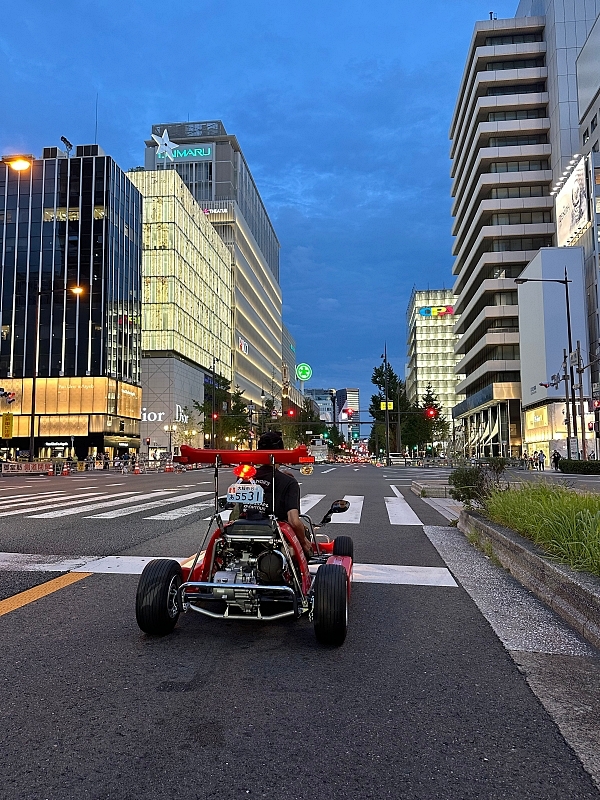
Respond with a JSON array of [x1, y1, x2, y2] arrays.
[[0, 0, 517, 408]]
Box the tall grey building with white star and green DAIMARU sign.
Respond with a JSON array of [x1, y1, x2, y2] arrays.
[[145, 121, 282, 403]]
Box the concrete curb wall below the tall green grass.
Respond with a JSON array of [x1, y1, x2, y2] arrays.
[[458, 511, 600, 648]]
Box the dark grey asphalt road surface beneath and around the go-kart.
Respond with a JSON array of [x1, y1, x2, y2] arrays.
[[0, 465, 600, 800]]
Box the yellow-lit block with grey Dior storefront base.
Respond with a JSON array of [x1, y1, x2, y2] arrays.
[[128, 170, 233, 456]]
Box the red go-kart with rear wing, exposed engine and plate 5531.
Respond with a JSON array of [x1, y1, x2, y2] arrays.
[[136, 445, 354, 646]]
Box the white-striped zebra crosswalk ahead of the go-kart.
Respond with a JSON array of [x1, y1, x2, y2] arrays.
[[0, 477, 450, 525]]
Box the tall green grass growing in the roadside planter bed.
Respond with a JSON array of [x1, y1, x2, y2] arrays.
[[485, 483, 600, 576]]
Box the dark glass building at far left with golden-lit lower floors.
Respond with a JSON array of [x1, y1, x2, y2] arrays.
[[0, 145, 141, 458]]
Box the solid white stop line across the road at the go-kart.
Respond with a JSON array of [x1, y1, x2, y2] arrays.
[[0, 553, 456, 586]]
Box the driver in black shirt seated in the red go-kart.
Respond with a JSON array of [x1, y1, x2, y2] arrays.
[[243, 431, 313, 558]]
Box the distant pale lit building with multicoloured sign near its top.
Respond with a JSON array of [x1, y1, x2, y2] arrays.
[[406, 289, 463, 421]]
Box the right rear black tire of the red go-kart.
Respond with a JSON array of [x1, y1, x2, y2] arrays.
[[313, 564, 348, 647]]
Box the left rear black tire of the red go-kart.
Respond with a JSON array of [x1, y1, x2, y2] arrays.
[[135, 558, 183, 636]]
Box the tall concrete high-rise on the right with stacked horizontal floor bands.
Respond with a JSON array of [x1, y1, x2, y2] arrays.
[[450, 0, 600, 456]]
